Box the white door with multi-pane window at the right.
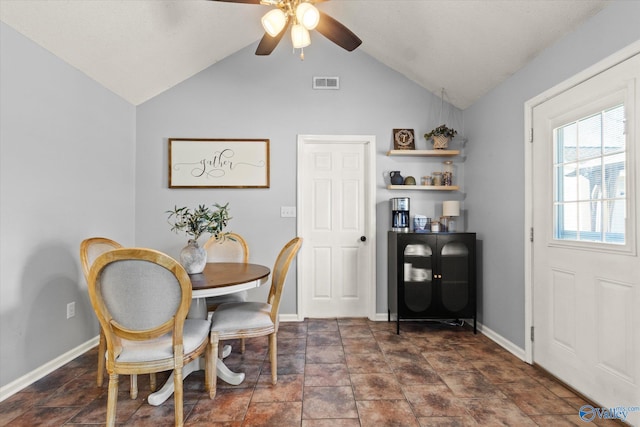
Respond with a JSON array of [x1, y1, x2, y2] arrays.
[[532, 55, 640, 425]]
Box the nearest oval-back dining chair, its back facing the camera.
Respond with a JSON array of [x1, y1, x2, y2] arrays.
[[89, 248, 213, 426]]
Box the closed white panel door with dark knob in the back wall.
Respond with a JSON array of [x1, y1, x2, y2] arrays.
[[298, 135, 376, 318]]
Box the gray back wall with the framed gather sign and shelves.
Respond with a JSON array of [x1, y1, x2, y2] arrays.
[[135, 36, 463, 314]]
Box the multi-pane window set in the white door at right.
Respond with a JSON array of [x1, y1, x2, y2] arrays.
[[554, 105, 626, 244]]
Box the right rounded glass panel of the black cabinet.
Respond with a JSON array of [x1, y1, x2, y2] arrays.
[[440, 242, 470, 312]]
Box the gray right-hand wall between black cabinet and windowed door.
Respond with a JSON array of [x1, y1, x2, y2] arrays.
[[464, 1, 640, 348]]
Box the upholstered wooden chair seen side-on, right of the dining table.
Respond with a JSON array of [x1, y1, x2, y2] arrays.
[[209, 237, 302, 399]]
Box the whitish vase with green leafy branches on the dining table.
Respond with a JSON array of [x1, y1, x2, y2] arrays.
[[166, 203, 231, 274]]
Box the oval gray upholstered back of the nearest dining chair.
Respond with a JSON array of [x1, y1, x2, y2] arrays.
[[89, 248, 191, 340]]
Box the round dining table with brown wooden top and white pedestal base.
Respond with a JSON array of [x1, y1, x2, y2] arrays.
[[148, 262, 271, 406]]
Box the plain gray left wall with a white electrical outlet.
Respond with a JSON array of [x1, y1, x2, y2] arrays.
[[0, 23, 135, 385]]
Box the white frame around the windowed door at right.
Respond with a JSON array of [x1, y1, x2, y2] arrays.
[[523, 41, 640, 364]]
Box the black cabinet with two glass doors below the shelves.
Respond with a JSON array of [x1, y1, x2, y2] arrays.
[[387, 231, 476, 334]]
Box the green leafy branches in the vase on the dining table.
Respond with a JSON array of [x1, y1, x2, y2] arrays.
[[166, 203, 231, 241]]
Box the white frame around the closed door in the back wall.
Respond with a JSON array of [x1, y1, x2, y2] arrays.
[[296, 135, 377, 321]]
